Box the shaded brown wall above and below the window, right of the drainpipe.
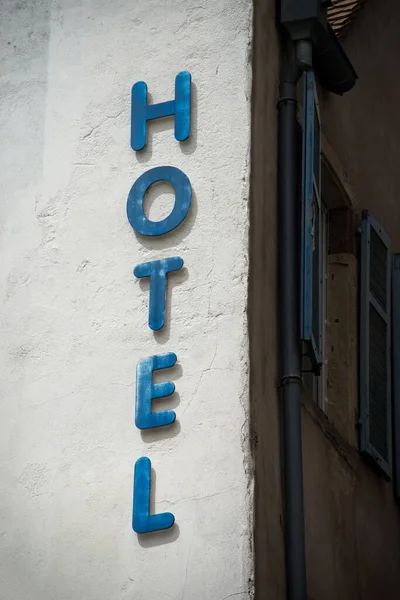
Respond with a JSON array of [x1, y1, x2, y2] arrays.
[[303, 0, 400, 600]]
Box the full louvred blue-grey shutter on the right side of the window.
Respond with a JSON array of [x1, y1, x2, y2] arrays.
[[360, 211, 392, 477]]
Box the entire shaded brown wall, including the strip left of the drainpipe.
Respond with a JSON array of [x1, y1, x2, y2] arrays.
[[249, 0, 400, 600]]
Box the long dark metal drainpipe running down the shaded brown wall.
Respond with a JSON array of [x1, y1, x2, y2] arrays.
[[278, 41, 312, 600]]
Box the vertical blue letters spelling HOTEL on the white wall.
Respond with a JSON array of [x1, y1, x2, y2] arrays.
[[126, 71, 192, 534]]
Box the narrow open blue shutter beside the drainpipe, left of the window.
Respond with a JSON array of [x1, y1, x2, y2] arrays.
[[300, 73, 323, 374]]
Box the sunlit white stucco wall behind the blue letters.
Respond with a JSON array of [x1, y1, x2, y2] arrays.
[[0, 0, 252, 600]]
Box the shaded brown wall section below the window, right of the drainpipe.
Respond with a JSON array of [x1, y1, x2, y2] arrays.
[[303, 403, 400, 600]]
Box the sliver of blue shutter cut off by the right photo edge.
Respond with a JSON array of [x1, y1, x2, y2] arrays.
[[392, 254, 400, 500]]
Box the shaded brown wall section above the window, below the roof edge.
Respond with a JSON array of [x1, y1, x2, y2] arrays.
[[320, 0, 400, 251]]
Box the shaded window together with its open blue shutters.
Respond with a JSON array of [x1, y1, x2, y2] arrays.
[[300, 73, 400, 486]]
